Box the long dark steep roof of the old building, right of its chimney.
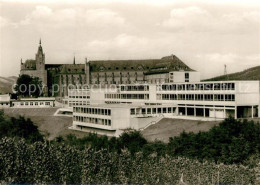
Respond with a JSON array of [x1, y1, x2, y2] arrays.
[[90, 55, 193, 73]]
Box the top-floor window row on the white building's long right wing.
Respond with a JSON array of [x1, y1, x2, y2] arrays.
[[157, 83, 235, 91]]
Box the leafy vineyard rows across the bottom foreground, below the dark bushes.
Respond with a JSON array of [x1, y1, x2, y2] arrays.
[[0, 138, 255, 184]]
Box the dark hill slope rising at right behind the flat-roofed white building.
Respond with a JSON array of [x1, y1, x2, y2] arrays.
[[203, 66, 260, 81]]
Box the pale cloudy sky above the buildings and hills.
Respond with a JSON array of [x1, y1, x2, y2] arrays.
[[0, 0, 260, 79]]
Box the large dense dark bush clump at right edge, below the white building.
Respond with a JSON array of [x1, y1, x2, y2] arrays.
[[169, 118, 260, 164]]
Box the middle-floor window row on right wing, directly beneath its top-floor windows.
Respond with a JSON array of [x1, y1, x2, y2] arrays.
[[157, 94, 235, 101]]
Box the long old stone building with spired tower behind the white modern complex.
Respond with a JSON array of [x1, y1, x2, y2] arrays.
[[20, 41, 200, 97]]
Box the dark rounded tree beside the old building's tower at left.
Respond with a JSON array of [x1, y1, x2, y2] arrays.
[[15, 74, 43, 97]]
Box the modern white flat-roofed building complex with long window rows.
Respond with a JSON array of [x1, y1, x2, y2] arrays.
[[69, 81, 260, 136]]
